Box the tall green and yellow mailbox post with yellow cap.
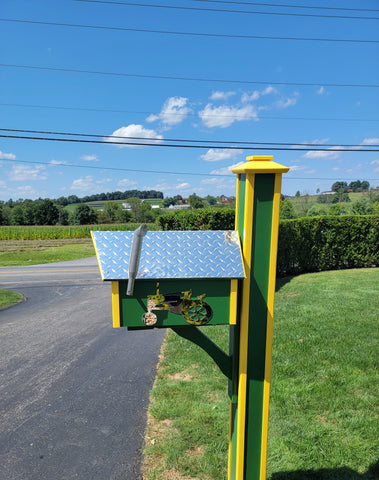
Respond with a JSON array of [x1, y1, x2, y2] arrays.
[[228, 156, 289, 480]]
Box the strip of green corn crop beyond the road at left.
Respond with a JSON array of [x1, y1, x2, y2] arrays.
[[0, 223, 157, 240]]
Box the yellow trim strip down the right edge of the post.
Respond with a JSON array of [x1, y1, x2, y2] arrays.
[[260, 173, 282, 480]]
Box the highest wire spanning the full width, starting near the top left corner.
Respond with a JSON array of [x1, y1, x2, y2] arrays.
[[0, 18, 379, 43]]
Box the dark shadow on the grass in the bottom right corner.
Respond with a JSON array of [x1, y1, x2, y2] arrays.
[[270, 461, 379, 480]]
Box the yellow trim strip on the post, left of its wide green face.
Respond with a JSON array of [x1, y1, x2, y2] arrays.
[[236, 175, 255, 480]]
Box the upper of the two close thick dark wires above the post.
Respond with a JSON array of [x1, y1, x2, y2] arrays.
[[0, 128, 379, 151]]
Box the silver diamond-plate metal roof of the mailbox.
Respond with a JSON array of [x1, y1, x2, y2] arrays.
[[92, 230, 245, 280]]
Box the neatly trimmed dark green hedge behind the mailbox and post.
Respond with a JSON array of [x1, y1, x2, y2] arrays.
[[157, 209, 379, 276]]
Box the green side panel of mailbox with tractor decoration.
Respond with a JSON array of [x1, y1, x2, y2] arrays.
[[119, 279, 230, 328]]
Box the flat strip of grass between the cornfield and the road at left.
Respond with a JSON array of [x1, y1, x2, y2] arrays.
[[0, 238, 95, 267]]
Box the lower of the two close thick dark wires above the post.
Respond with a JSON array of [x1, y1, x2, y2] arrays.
[[0, 134, 379, 152]]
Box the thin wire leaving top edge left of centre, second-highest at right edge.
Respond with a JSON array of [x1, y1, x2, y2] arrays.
[[75, 0, 379, 20]]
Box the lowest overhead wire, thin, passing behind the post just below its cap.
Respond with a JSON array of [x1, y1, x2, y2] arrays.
[[2, 159, 379, 182]]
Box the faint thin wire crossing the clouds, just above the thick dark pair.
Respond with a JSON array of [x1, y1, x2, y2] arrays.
[[0, 103, 379, 122]]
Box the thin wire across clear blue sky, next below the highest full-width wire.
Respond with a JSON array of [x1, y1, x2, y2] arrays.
[[0, 63, 379, 88]]
